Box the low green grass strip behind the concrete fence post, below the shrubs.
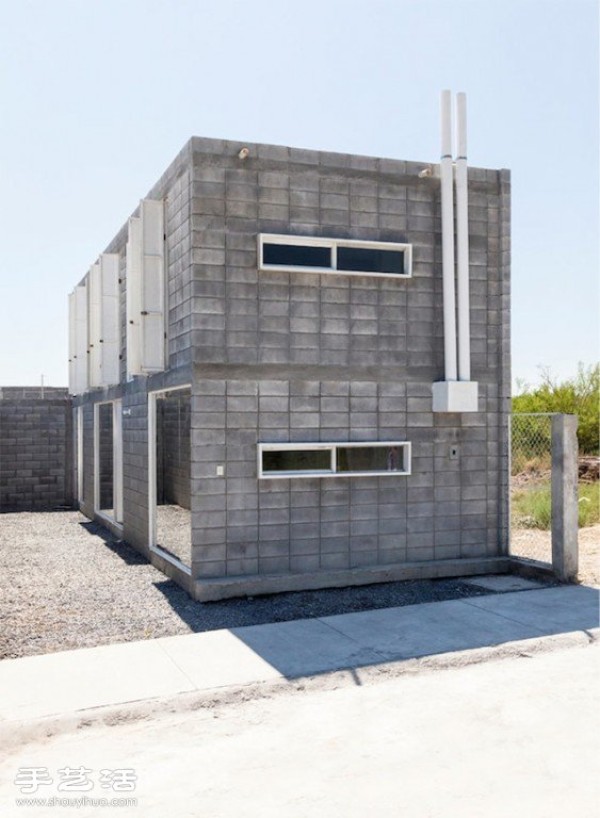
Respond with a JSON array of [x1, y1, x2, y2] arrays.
[[511, 482, 600, 530]]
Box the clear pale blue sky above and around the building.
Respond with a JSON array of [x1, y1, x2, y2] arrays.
[[0, 0, 599, 385]]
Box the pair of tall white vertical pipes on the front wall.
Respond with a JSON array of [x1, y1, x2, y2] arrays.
[[440, 91, 471, 381]]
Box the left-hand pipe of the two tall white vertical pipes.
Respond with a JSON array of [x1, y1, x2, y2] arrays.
[[440, 91, 457, 381]]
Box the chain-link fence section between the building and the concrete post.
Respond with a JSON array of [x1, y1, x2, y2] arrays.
[[510, 414, 552, 563]]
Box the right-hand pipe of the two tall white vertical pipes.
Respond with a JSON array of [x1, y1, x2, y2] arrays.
[[456, 93, 471, 381]]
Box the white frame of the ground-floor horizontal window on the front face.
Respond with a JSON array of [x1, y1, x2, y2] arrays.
[[257, 440, 412, 480]]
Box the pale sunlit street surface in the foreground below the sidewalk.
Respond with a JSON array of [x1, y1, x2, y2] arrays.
[[0, 644, 600, 818]]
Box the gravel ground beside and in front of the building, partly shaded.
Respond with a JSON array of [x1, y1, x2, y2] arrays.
[[0, 511, 502, 658]]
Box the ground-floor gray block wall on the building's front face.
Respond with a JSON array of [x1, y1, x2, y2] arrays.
[[192, 376, 506, 579]]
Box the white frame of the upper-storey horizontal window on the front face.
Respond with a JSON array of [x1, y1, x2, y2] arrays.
[[258, 233, 412, 279]]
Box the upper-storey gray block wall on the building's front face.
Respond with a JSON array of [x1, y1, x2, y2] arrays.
[[191, 139, 505, 380]]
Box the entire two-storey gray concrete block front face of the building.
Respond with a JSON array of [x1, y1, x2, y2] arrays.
[[185, 139, 510, 583]]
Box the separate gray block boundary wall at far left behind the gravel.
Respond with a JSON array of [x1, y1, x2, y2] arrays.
[[0, 387, 72, 511]]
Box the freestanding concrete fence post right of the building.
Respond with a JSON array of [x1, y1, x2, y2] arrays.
[[552, 415, 579, 580]]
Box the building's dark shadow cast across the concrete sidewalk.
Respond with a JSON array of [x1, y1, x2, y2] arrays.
[[227, 585, 599, 679]]
